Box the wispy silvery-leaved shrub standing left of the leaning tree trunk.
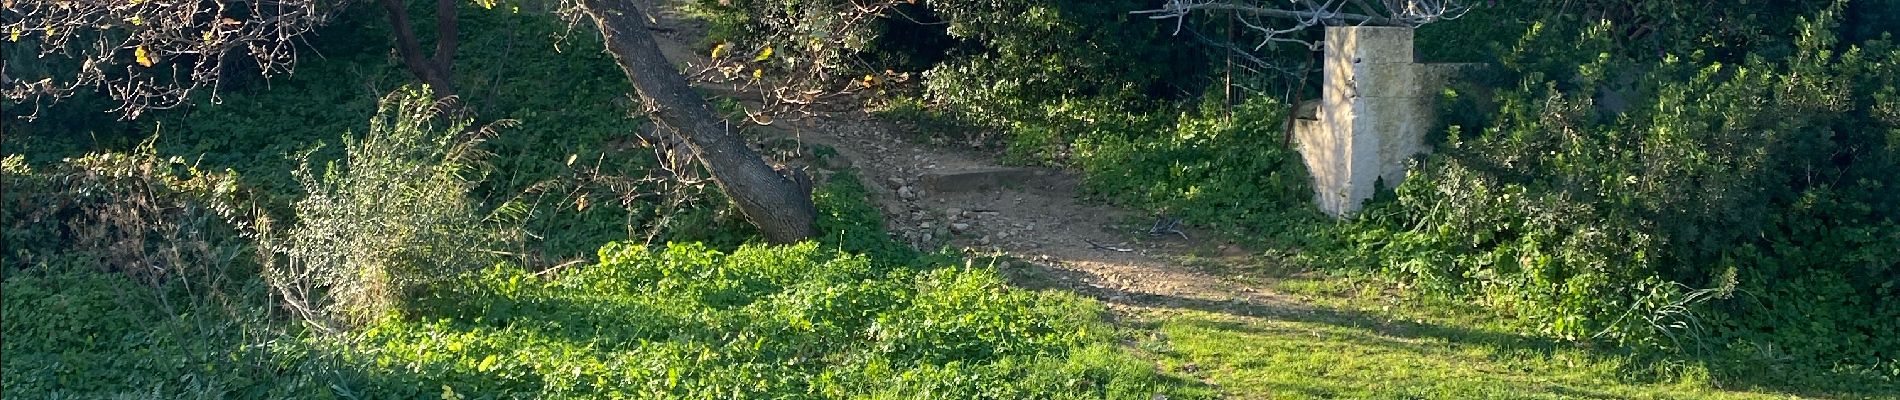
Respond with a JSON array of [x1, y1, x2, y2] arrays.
[[258, 89, 513, 328]]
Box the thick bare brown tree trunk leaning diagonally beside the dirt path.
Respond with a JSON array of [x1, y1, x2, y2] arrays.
[[580, 0, 817, 243]]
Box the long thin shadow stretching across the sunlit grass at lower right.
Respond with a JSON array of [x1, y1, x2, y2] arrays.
[[1005, 262, 1900, 398]]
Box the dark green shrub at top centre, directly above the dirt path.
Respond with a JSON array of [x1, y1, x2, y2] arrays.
[[923, 0, 1208, 163]]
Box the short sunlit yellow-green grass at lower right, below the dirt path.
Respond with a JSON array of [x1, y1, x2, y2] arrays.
[[1138, 271, 1896, 398]]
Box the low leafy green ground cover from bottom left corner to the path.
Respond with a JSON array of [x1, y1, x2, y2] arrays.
[[4, 243, 1207, 398]]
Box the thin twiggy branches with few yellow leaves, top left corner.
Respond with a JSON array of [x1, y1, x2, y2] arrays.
[[0, 0, 348, 118]]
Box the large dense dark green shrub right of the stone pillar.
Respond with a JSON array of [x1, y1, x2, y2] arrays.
[[1347, 6, 1900, 379]]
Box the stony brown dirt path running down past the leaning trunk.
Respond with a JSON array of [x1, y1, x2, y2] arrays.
[[638, 8, 1305, 315]]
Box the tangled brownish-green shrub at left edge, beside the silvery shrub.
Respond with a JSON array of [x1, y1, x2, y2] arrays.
[[0, 142, 247, 284]]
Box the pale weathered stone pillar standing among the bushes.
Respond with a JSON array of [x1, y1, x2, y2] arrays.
[[1294, 27, 1444, 216]]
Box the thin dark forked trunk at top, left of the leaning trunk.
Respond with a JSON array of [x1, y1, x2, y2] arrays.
[[380, 0, 460, 99]]
